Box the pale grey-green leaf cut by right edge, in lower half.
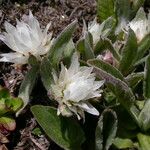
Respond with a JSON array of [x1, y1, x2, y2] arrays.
[[139, 99, 150, 131]]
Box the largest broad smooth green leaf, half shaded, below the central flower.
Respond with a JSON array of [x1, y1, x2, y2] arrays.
[[31, 105, 84, 150]]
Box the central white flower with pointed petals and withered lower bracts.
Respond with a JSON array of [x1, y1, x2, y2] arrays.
[[50, 53, 104, 119]]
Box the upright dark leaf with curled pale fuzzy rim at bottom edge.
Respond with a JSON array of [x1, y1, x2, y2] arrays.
[[96, 109, 118, 150]]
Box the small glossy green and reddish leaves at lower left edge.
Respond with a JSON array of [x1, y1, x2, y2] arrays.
[[0, 87, 23, 143]]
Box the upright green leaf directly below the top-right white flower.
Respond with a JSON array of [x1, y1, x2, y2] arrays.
[[119, 29, 137, 75]]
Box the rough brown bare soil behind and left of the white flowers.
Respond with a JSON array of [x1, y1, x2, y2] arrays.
[[0, 0, 96, 150]]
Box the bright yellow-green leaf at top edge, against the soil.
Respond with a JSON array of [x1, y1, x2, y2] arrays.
[[97, 0, 114, 21]]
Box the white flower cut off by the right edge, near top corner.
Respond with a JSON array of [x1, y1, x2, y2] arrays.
[[129, 8, 150, 42]]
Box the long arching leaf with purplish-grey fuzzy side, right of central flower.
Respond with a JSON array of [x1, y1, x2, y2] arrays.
[[88, 60, 139, 122]]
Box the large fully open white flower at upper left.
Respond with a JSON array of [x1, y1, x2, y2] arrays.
[[0, 11, 52, 64]]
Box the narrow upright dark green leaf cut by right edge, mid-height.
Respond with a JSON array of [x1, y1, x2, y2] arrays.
[[143, 55, 150, 98]]
